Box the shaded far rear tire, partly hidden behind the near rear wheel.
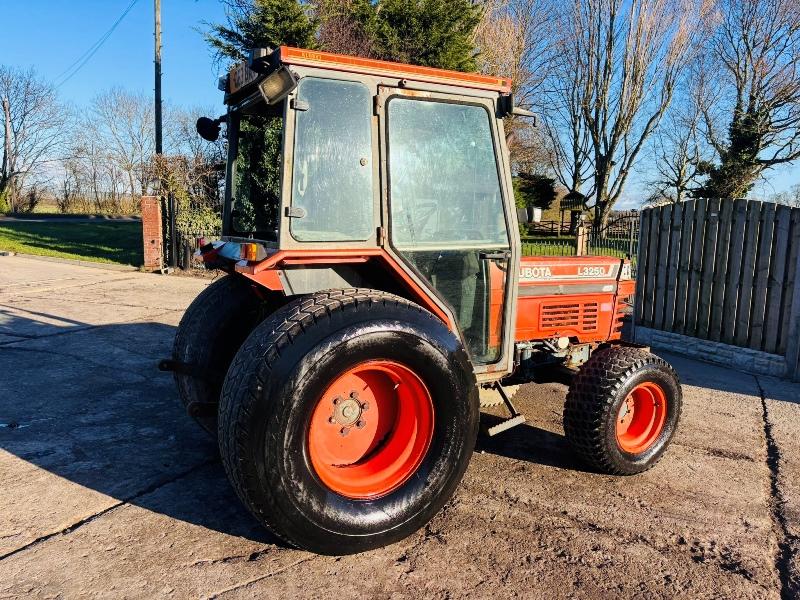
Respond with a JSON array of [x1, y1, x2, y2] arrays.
[[172, 275, 261, 437]]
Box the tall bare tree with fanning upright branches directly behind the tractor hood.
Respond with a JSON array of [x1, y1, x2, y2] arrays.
[[564, 0, 708, 224]]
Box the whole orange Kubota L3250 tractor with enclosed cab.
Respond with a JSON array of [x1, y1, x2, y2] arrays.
[[161, 47, 681, 554]]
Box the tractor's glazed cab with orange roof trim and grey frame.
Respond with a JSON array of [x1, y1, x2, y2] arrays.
[[201, 47, 520, 371]]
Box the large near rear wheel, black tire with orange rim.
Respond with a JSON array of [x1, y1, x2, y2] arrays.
[[219, 289, 479, 555]]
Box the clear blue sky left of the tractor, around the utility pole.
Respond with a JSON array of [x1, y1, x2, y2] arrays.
[[0, 0, 231, 108]]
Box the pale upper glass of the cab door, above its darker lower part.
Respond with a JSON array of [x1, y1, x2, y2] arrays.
[[389, 98, 508, 248]]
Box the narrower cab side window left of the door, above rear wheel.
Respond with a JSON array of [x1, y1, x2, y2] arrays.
[[290, 78, 374, 242]]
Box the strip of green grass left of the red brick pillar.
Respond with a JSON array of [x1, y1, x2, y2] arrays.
[[0, 221, 142, 266]]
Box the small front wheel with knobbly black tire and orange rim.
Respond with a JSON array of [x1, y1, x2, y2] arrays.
[[564, 346, 682, 475]]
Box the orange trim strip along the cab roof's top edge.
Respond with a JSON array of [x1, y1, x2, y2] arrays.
[[280, 46, 511, 94]]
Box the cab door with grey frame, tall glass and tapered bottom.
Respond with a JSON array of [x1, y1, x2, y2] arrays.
[[379, 88, 516, 372]]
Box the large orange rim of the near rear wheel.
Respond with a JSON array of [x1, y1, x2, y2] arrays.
[[308, 360, 434, 499]]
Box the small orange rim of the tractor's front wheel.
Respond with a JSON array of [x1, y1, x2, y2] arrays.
[[617, 381, 667, 454]]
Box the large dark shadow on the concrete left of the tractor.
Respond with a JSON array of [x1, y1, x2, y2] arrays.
[[0, 308, 278, 546]]
